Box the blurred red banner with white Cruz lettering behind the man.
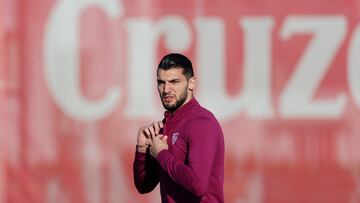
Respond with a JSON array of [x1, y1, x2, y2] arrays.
[[0, 0, 360, 203]]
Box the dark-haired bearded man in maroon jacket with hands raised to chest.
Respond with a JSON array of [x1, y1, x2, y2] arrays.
[[133, 53, 224, 203]]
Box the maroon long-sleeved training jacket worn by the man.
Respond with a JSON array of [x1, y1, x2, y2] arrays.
[[133, 98, 224, 203]]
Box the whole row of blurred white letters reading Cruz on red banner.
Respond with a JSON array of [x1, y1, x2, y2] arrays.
[[44, 11, 360, 121]]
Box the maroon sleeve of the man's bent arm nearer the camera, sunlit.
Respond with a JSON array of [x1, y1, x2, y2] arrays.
[[157, 117, 223, 196]]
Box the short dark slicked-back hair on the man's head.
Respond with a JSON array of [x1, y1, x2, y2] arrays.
[[158, 53, 194, 79]]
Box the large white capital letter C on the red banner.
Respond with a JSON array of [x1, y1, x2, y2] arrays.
[[43, 0, 122, 121]]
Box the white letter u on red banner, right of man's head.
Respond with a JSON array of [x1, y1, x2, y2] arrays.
[[195, 17, 274, 119]]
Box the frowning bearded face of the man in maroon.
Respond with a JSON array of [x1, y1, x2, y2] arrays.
[[157, 68, 191, 112]]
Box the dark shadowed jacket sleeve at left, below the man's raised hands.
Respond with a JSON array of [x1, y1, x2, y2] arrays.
[[133, 151, 159, 194]]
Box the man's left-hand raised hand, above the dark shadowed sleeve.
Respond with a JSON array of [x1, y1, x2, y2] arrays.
[[136, 121, 164, 153]]
